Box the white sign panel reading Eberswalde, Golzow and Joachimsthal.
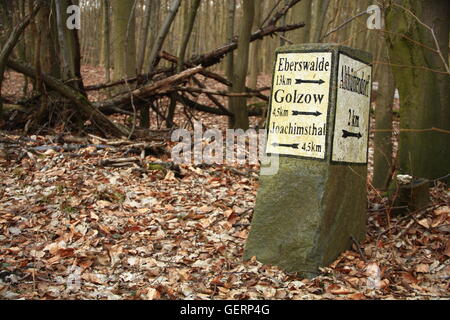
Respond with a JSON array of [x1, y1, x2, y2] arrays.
[[266, 52, 332, 159]]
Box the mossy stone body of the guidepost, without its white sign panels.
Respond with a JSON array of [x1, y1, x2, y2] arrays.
[[244, 44, 372, 277]]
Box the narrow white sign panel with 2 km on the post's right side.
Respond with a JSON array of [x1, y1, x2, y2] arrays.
[[331, 53, 372, 163]]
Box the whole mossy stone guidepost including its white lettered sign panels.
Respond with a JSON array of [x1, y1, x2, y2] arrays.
[[244, 44, 372, 276]]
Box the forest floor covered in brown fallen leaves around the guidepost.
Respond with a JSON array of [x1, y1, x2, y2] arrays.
[[0, 69, 450, 300]]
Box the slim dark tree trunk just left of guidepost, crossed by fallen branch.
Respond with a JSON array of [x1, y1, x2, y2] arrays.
[[230, 0, 255, 129]]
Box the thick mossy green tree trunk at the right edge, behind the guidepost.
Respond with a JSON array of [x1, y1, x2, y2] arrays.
[[386, 0, 450, 179]]
